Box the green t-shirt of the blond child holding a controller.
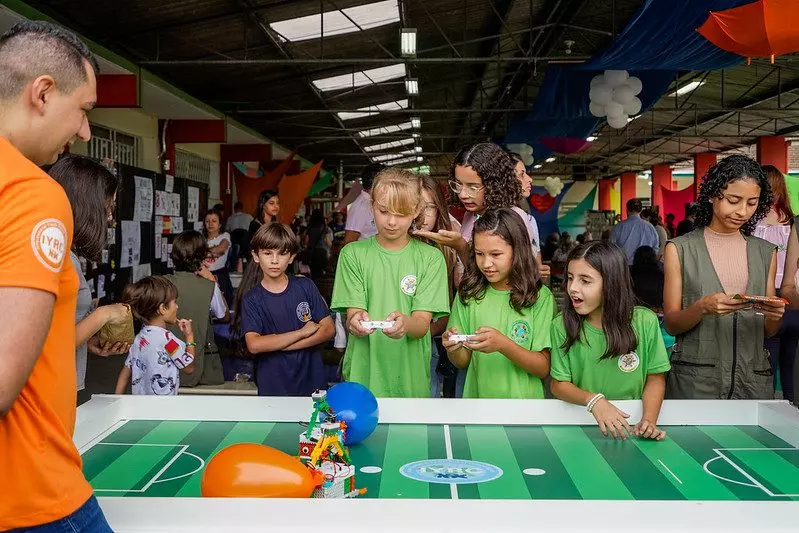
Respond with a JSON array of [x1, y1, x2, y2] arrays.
[[330, 237, 449, 398]]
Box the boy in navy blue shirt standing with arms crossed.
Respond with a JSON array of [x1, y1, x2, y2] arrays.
[[240, 222, 335, 396]]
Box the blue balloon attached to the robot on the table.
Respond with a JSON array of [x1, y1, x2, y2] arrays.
[[327, 381, 380, 446]]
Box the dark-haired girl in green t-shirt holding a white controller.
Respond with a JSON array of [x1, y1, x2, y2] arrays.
[[442, 208, 555, 398]]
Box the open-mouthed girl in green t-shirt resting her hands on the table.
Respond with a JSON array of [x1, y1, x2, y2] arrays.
[[551, 241, 670, 440]]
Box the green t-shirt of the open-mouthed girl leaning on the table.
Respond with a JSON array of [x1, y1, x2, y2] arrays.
[[550, 307, 671, 400]]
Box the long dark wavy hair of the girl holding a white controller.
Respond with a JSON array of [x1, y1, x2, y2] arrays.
[[458, 208, 541, 313]]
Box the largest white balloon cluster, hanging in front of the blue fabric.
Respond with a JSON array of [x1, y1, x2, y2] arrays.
[[588, 70, 643, 129]]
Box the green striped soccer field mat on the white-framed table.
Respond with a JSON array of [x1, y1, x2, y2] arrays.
[[83, 420, 799, 501]]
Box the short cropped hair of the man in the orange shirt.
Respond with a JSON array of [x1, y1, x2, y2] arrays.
[[0, 20, 99, 101]]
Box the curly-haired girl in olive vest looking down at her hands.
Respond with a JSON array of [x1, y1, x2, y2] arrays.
[[663, 155, 785, 399]]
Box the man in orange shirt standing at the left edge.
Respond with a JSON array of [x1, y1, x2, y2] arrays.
[[0, 22, 111, 532]]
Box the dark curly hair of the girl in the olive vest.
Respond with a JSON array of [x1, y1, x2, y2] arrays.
[[694, 154, 772, 235]]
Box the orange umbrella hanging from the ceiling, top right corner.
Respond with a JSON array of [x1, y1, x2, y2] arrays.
[[696, 0, 799, 63]]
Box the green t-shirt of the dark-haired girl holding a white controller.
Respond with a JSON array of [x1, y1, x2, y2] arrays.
[[448, 286, 555, 399]]
